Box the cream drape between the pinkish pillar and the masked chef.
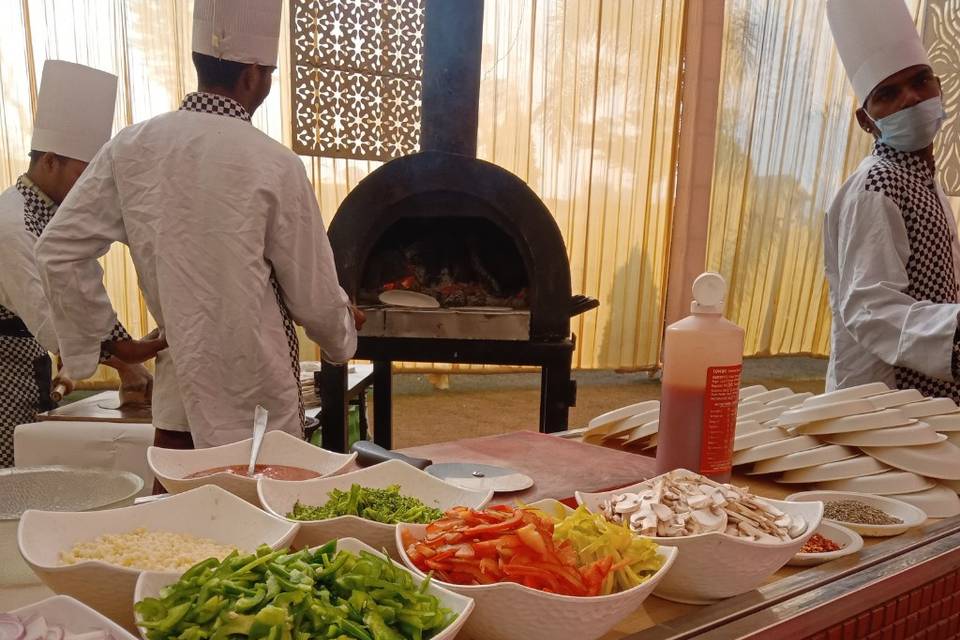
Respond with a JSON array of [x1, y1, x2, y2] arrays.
[[707, 0, 960, 355]]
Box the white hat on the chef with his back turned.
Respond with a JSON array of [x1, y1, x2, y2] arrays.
[[193, 0, 283, 67]]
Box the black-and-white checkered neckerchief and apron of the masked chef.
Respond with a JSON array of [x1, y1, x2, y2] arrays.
[[865, 143, 960, 403]]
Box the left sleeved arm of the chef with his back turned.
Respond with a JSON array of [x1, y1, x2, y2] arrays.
[[35, 148, 126, 379]]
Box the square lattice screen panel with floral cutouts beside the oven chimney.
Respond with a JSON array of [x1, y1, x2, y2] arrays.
[[290, 0, 425, 160]]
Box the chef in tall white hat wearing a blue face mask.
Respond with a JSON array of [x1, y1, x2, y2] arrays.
[[823, 0, 960, 402]]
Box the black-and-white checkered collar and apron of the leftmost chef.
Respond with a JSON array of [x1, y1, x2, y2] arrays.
[[0, 178, 56, 467]]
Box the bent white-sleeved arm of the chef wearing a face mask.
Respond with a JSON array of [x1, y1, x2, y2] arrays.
[[836, 192, 960, 380]]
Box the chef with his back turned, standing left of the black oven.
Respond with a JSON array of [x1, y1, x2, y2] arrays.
[[37, 0, 362, 456]]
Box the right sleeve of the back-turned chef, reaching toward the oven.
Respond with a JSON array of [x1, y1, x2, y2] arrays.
[[265, 166, 357, 363]]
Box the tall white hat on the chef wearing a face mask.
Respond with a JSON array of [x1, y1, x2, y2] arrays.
[[827, 0, 930, 104]]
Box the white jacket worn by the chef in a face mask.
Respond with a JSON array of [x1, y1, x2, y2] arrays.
[[823, 155, 960, 391]]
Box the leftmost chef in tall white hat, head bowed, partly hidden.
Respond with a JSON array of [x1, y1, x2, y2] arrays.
[[0, 60, 159, 467]]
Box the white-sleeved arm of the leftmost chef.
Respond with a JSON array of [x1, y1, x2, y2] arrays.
[[0, 228, 60, 353]]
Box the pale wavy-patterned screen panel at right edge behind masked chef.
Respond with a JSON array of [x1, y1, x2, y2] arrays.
[[923, 0, 960, 196]]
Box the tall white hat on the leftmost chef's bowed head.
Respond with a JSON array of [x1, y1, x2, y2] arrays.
[[30, 60, 117, 162]]
